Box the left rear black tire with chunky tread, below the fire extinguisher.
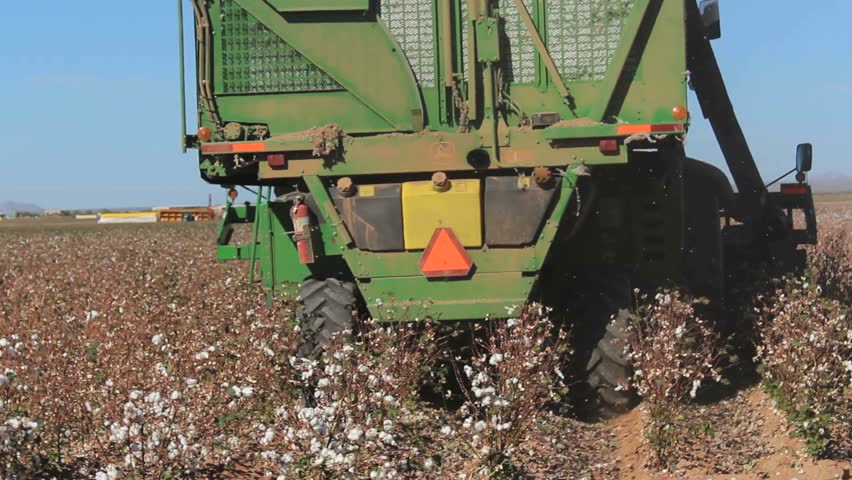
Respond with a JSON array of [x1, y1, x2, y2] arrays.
[[297, 278, 357, 360]]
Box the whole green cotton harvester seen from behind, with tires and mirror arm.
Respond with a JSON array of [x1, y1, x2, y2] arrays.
[[179, 0, 816, 408]]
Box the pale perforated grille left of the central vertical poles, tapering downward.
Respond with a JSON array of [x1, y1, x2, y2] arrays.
[[379, 0, 436, 87]]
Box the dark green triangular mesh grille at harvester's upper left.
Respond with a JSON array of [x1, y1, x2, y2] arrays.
[[222, 0, 342, 93]]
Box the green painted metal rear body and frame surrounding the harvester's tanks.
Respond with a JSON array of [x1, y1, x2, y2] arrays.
[[186, 0, 691, 320]]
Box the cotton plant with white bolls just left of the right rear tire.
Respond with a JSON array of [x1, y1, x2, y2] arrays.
[[452, 304, 571, 478]]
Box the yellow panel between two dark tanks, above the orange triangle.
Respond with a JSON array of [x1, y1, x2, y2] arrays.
[[402, 180, 482, 250]]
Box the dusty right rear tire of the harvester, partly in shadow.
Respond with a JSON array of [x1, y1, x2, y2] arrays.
[[580, 275, 639, 418]]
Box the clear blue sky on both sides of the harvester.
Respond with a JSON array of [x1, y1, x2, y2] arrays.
[[0, 0, 852, 208]]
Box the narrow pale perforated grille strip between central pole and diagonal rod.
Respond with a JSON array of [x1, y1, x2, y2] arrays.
[[500, 0, 535, 83]]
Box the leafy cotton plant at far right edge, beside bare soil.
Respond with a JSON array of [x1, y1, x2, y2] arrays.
[[757, 278, 852, 459]]
